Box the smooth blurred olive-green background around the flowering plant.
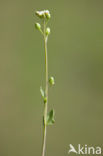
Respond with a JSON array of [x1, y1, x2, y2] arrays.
[[0, 0, 103, 156]]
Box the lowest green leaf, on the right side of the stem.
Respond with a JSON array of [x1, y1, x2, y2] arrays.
[[46, 109, 55, 125]]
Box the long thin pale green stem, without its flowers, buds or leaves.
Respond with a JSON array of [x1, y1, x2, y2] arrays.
[[42, 20, 48, 156]]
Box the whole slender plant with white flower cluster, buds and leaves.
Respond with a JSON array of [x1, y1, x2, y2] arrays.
[[35, 10, 55, 156]]
